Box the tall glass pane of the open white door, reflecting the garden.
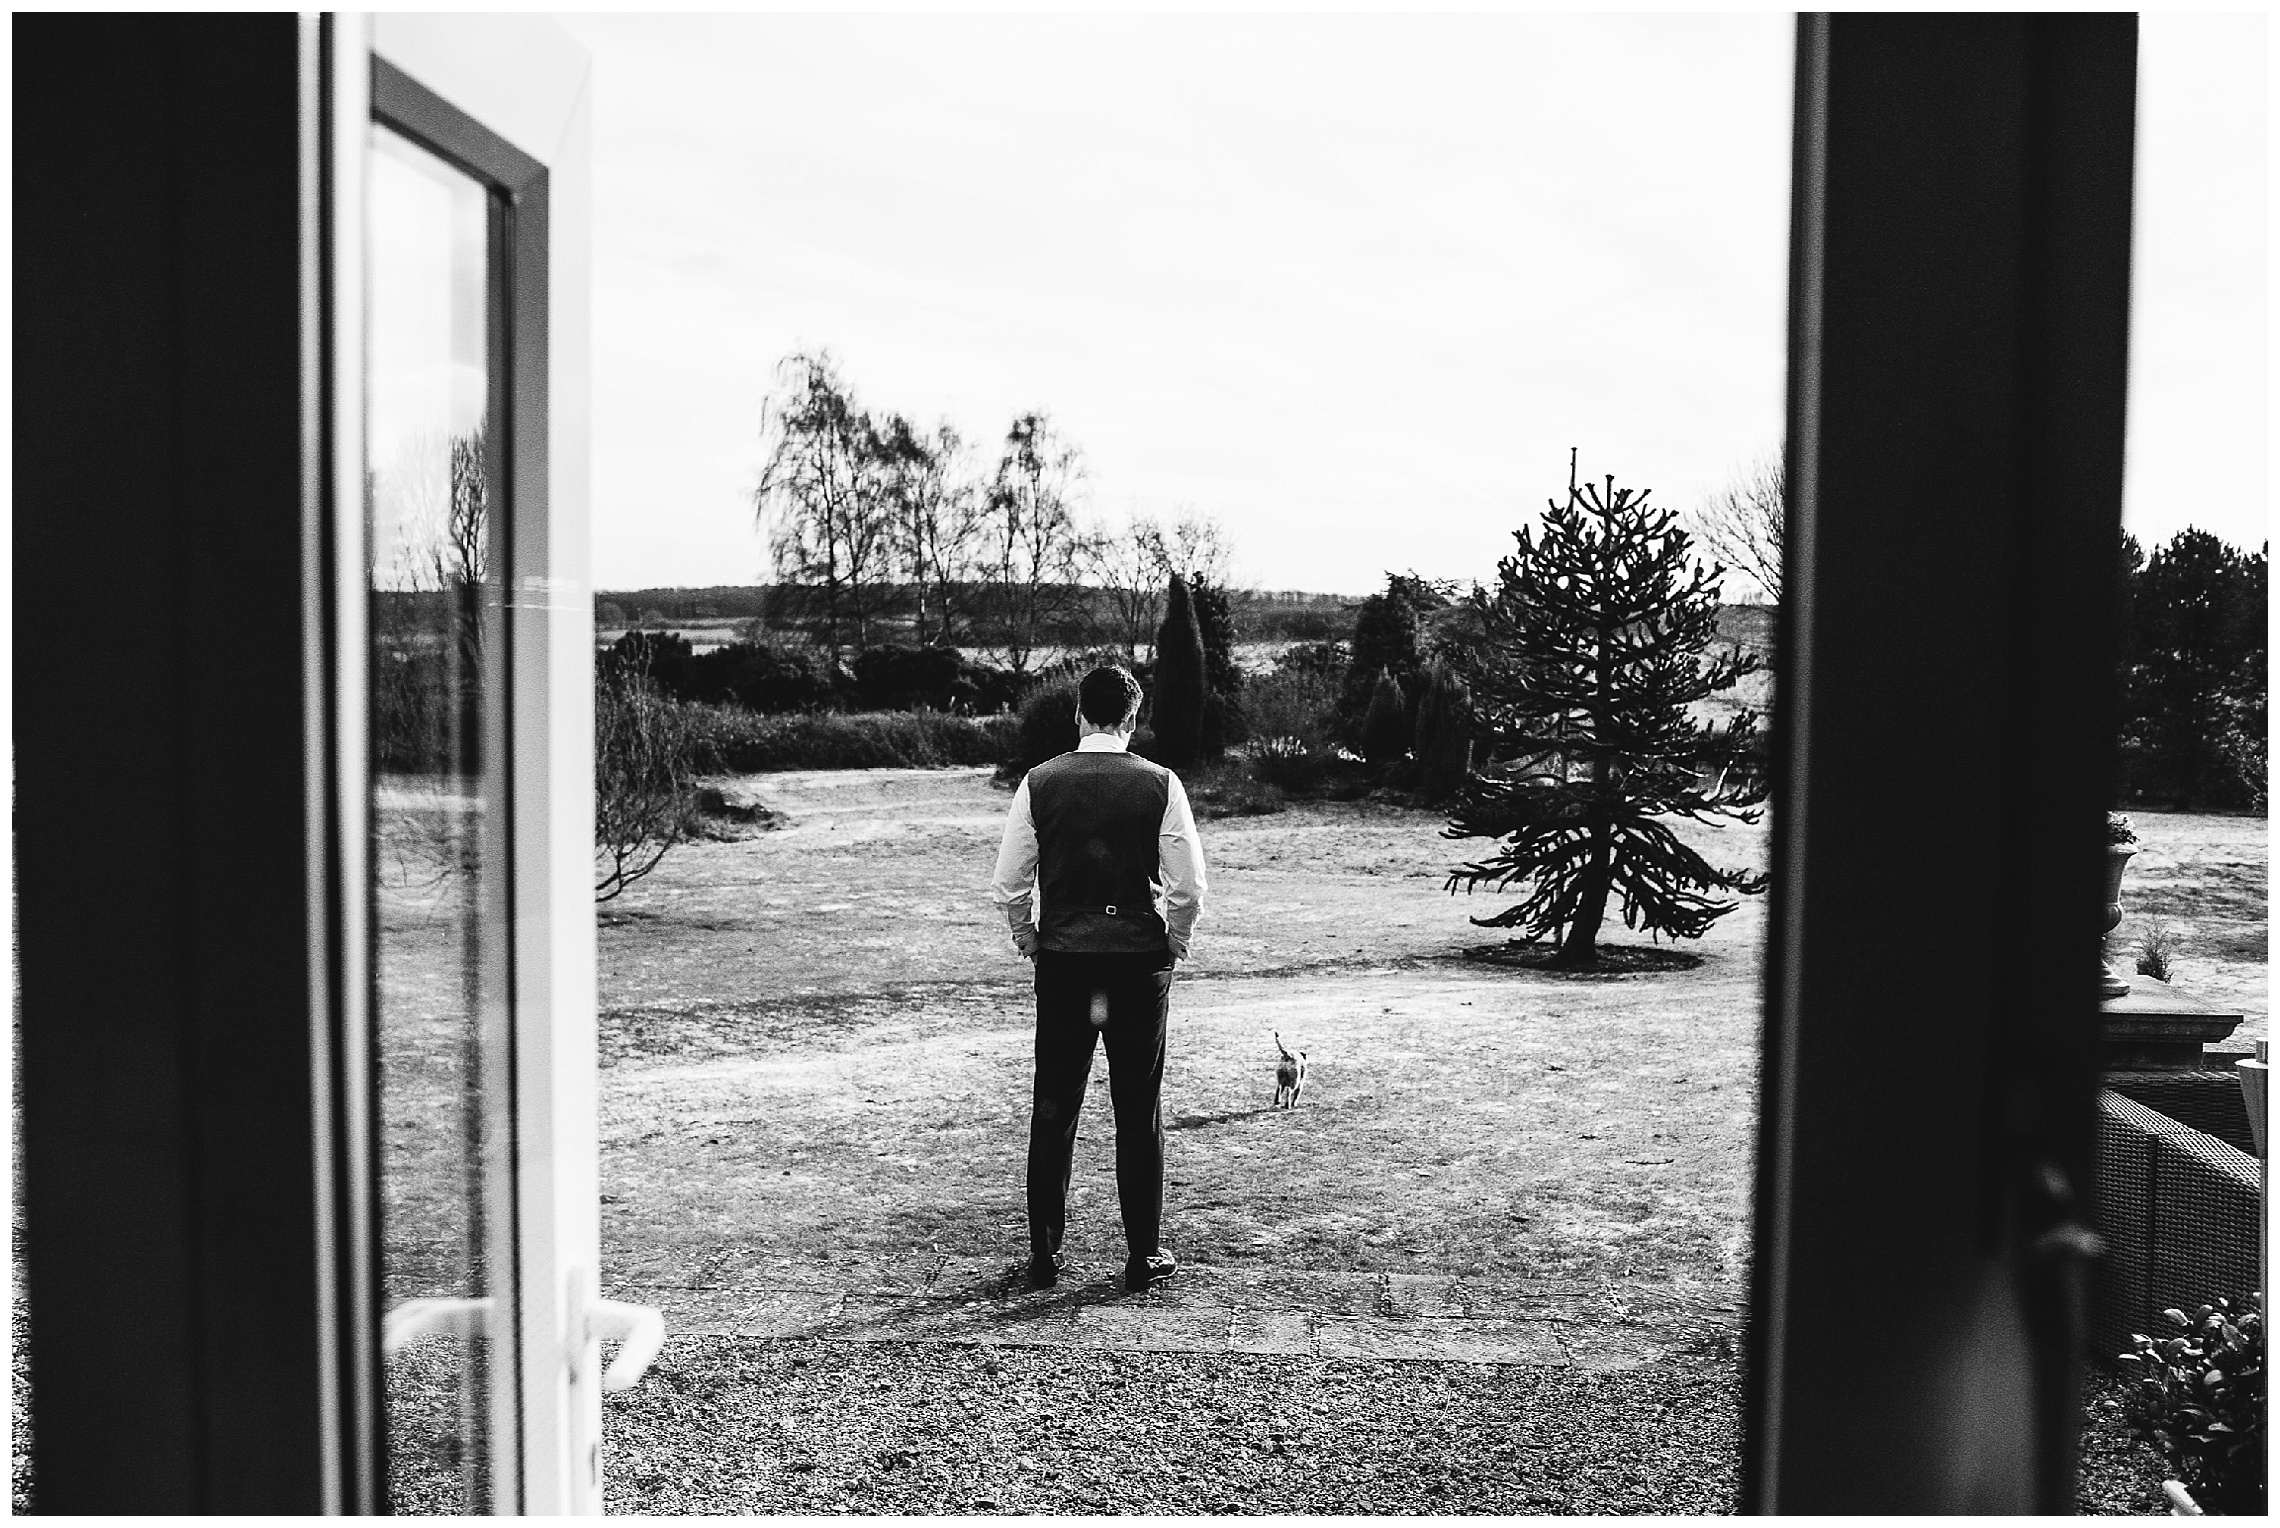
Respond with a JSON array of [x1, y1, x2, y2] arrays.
[[367, 125, 511, 1512]]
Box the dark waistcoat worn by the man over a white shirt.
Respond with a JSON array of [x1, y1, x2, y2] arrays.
[[1028, 753, 1172, 956]]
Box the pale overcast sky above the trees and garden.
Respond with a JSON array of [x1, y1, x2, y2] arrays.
[[547, 16, 2266, 593]]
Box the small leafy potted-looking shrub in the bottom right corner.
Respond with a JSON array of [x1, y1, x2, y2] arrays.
[[2120, 1295, 2264, 1517]]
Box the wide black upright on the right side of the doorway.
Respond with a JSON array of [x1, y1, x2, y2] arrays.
[[1746, 14, 2136, 1512]]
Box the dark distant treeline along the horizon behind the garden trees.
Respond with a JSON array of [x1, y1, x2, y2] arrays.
[[593, 584, 1361, 648]]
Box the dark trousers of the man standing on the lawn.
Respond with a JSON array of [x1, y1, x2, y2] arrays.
[[1028, 949, 1172, 1257]]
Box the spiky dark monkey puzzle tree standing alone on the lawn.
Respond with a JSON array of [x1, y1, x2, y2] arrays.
[[1443, 458, 1767, 969]]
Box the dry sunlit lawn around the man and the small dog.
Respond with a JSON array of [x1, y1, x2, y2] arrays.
[[602, 771, 2264, 1352]]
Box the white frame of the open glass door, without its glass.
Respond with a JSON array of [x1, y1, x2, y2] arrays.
[[333, 16, 602, 1514]]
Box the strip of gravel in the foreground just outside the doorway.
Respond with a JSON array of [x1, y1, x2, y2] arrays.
[[606, 1336, 1740, 1514]]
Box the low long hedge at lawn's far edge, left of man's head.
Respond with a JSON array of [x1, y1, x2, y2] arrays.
[[691, 707, 1015, 773]]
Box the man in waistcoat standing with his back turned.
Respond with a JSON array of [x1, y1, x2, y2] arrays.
[[990, 668, 1204, 1291]]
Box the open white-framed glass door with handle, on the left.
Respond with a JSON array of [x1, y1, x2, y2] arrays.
[[333, 16, 661, 1514]]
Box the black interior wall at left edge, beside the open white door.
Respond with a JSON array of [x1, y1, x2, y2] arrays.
[[11, 14, 321, 1512]]
